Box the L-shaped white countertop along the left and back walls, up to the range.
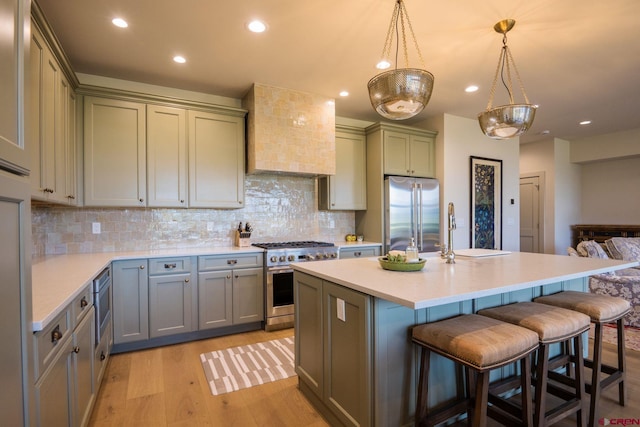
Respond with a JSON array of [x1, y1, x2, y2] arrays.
[[31, 246, 264, 332]]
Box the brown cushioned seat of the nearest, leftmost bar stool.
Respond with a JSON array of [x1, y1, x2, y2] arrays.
[[413, 314, 539, 370]]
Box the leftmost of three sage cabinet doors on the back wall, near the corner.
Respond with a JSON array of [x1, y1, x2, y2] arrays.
[[84, 96, 147, 207]]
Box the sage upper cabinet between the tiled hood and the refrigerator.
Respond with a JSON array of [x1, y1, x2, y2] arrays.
[[318, 126, 367, 210]]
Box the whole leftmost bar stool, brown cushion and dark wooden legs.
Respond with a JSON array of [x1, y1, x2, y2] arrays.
[[413, 314, 538, 426]]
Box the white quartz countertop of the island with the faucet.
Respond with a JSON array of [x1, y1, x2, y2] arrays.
[[293, 252, 639, 309]]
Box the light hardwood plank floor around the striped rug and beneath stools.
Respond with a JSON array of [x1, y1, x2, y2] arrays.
[[89, 329, 640, 427]]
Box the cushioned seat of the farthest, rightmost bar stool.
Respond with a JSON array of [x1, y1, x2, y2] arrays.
[[535, 291, 631, 323]]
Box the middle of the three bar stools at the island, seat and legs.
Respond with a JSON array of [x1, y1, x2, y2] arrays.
[[478, 302, 589, 427]]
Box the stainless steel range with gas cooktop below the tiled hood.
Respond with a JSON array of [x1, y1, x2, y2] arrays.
[[253, 241, 338, 331]]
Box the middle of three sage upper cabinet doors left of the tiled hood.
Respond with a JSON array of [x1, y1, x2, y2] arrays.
[[147, 105, 188, 208]]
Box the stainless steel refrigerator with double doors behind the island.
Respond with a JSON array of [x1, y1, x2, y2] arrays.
[[384, 176, 440, 253]]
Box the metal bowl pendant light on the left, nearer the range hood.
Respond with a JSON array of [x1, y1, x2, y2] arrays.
[[367, 0, 433, 120]]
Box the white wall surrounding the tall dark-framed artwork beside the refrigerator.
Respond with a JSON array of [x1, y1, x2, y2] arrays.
[[420, 114, 520, 251]]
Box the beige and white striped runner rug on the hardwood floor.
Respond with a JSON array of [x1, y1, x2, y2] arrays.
[[200, 337, 296, 396]]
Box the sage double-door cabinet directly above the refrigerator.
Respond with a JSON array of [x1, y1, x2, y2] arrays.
[[366, 123, 436, 178]]
